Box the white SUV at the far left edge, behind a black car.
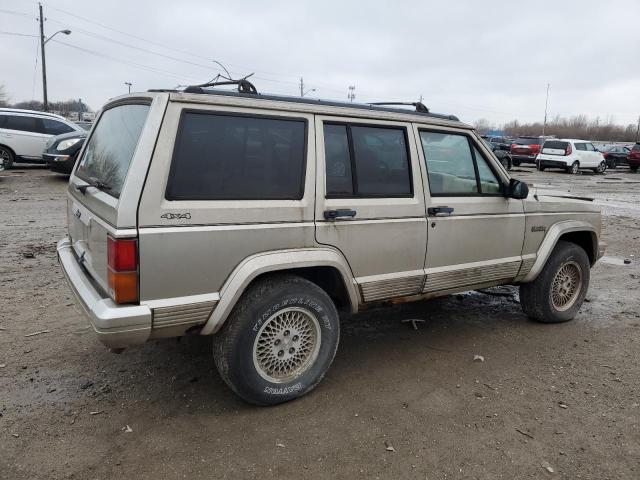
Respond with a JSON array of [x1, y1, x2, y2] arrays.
[[0, 108, 84, 169]]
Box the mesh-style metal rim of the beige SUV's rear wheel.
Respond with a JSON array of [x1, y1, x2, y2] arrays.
[[253, 307, 321, 383]]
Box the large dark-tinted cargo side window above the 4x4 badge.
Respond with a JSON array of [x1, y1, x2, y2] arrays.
[[166, 112, 306, 200]]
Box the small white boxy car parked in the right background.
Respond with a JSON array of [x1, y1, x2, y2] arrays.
[[536, 138, 607, 174]]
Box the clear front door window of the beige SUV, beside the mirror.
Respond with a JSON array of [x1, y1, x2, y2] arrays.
[[420, 131, 502, 196]]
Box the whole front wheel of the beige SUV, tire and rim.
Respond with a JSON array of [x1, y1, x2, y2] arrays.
[[520, 240, 591, 323]]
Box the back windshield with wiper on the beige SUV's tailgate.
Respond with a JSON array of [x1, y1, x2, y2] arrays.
[[76, 105, 150, 197]]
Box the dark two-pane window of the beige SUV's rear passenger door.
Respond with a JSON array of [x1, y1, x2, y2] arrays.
[[324, 124, 413, 197]]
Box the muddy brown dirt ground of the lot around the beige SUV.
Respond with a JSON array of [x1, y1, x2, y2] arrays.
[[0, 163, 640, 480]]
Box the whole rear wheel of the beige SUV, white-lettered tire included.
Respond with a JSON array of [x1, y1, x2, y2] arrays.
[[214, 275, 340, 405]]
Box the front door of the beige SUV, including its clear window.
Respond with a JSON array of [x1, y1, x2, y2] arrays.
[[416, 127, 525, 293]]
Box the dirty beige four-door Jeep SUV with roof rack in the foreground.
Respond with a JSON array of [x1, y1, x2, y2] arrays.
[[58, 87, 604, 405]]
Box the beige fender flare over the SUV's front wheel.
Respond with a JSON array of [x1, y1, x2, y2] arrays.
[[522, 220, 599, 283]]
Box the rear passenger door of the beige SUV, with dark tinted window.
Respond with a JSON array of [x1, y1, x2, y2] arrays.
[[315, 117, 427, 302]]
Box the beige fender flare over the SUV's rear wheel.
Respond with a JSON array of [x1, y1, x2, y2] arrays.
[[200, 248, 359, 335]]
